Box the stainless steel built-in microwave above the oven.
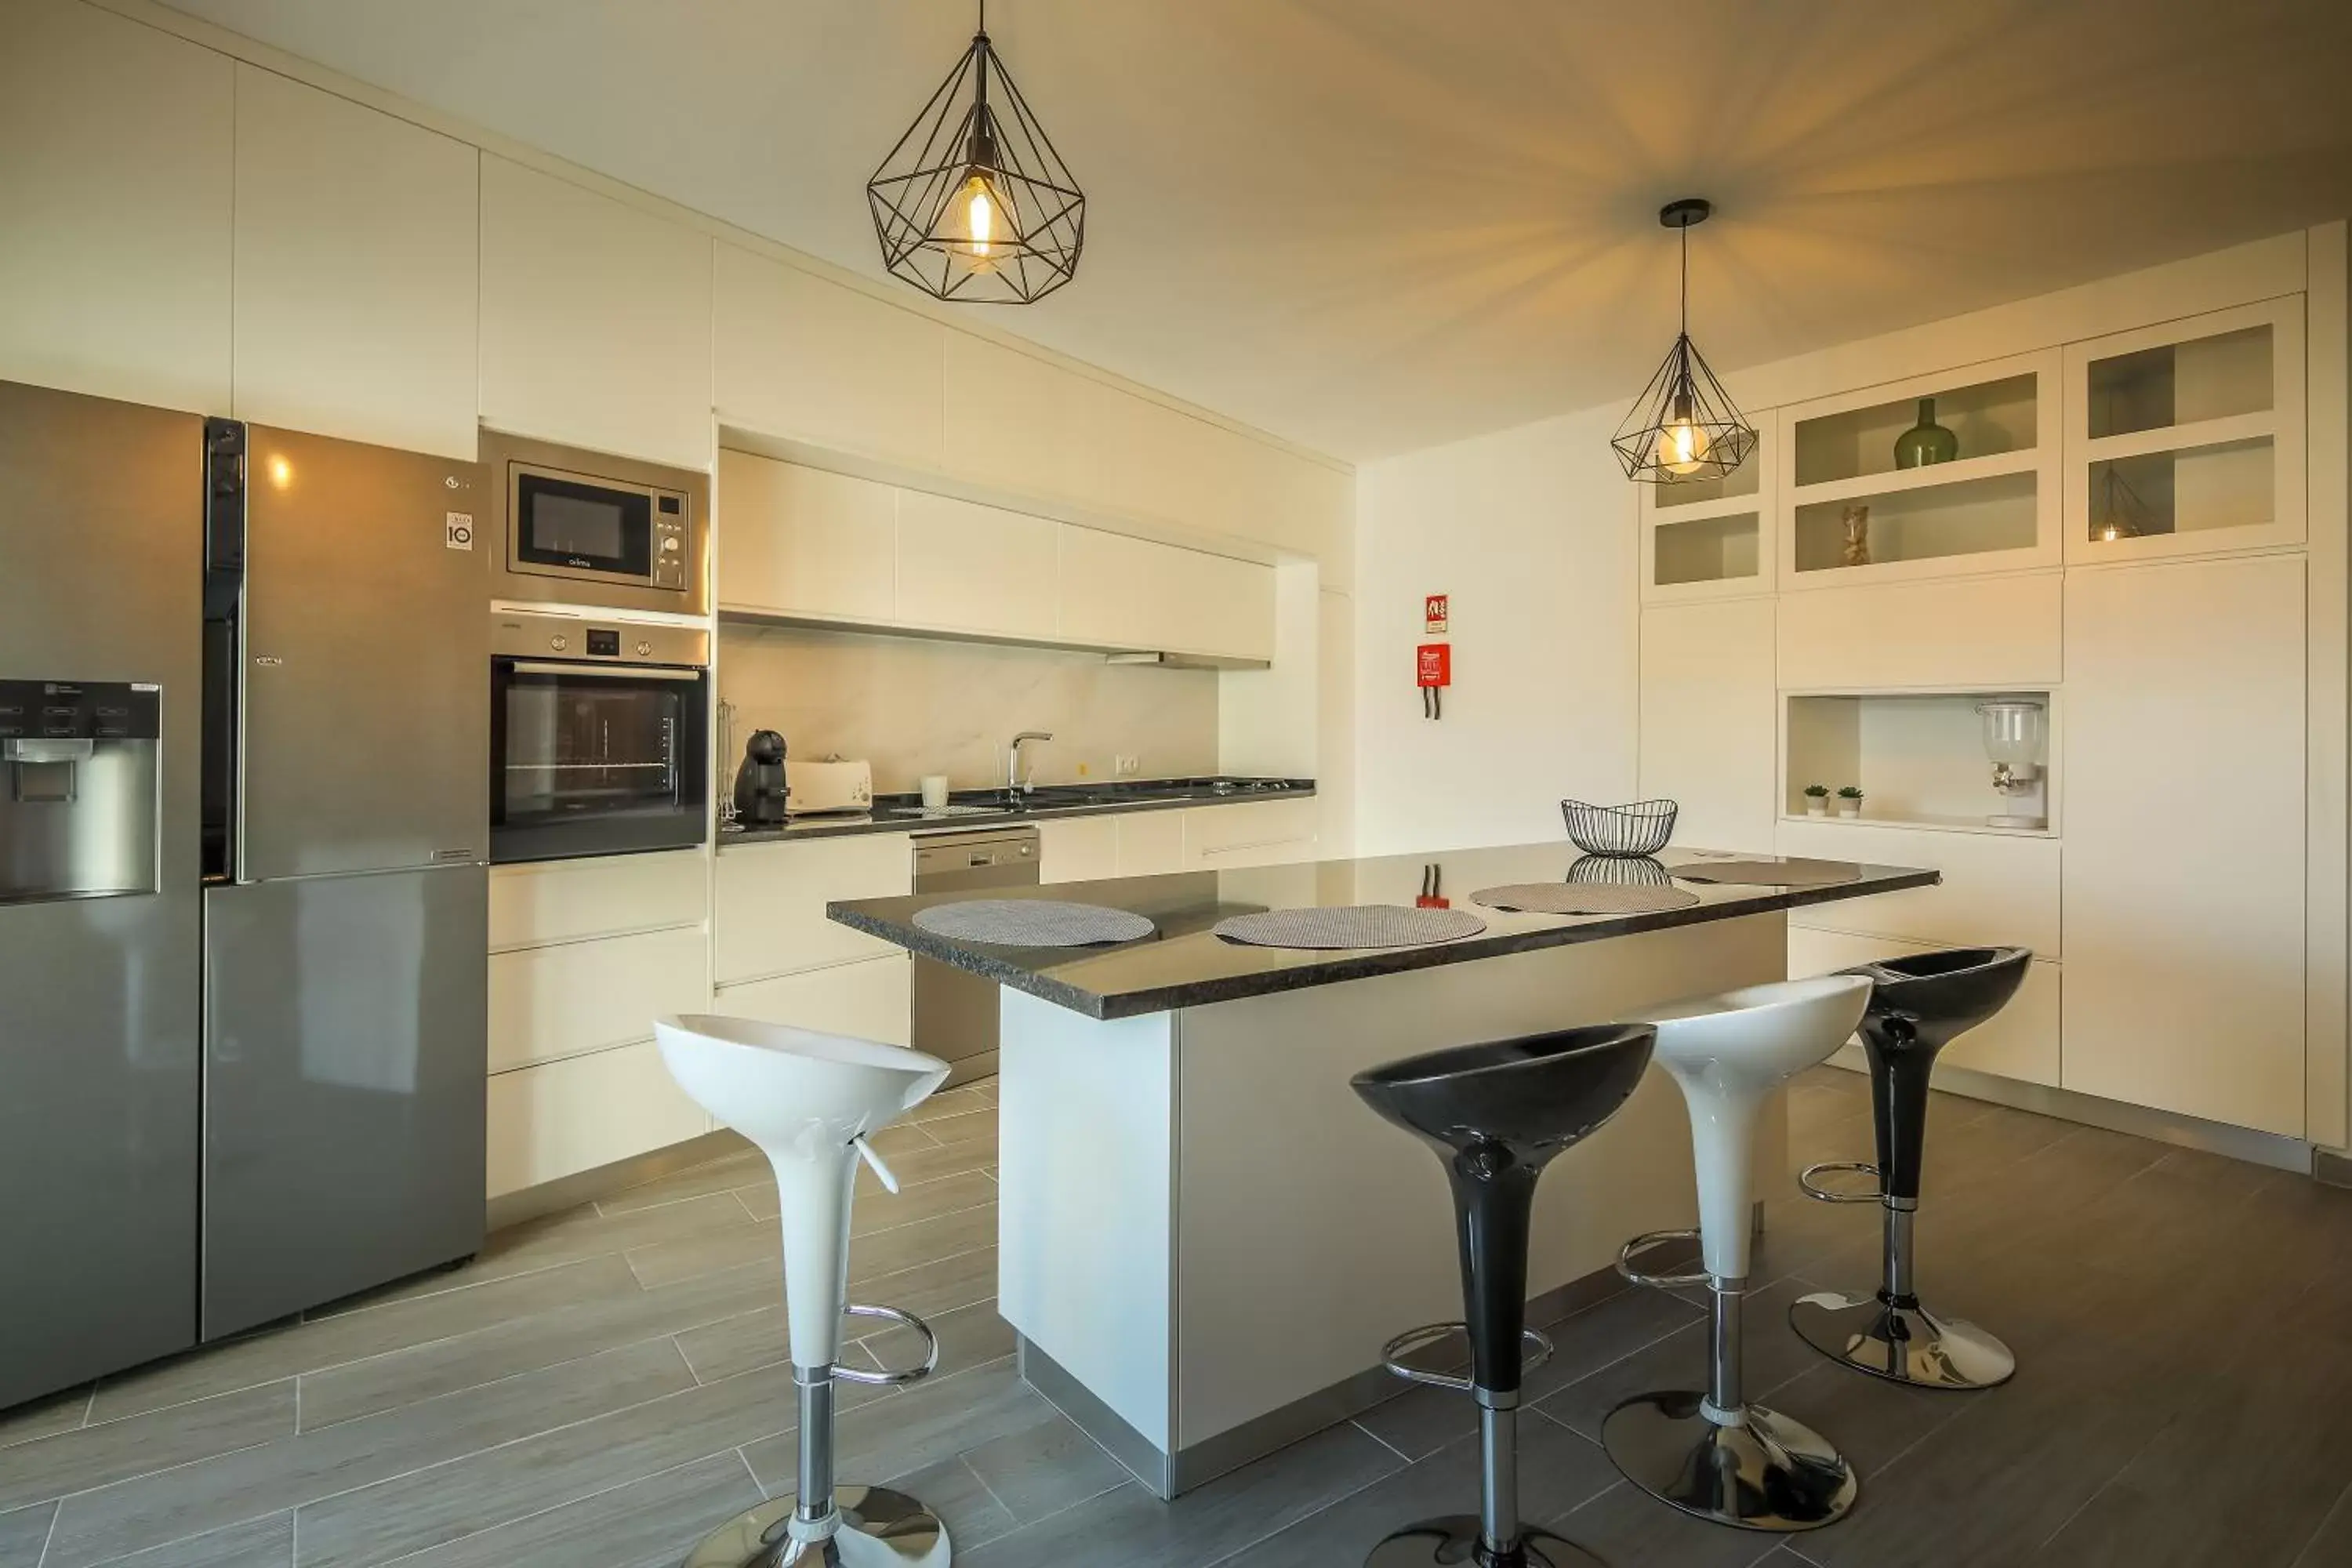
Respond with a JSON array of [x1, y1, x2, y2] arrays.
[[482, 433, 710, 616]]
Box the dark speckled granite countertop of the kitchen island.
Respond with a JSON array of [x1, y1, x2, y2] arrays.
[[826, 844, 1943, 1018]]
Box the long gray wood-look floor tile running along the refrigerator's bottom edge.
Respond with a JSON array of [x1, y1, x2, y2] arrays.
[[92, 1255, 637, 1420]]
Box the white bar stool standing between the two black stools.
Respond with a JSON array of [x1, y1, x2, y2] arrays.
[[1602, 975, 1870, 1530]]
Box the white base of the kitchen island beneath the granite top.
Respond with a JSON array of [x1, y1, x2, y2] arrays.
[[997, 914, 1788, 1497]]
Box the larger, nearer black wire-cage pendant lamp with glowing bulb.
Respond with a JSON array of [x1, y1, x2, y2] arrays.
[[866, 0, 1087, 306]]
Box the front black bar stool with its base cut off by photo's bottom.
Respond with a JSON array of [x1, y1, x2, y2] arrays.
[[1355, 1022, 1658, 1568]]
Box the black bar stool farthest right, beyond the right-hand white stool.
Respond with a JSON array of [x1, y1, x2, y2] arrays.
[[1788, 947, 2034, 1389]]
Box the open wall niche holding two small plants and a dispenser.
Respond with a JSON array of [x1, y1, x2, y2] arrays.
[[1780, 691, 2058, 837]]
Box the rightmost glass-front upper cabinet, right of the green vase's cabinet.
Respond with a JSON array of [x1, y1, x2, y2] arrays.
[[2065, 296, 2303, 564]]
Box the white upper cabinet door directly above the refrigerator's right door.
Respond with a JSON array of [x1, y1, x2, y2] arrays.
[[235, 64, 482, 463]]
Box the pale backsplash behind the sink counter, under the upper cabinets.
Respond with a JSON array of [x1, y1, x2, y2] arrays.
[[720, 626, 1216, 792]]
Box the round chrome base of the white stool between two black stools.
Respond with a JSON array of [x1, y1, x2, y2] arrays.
[[1602, 1392, 1858, 1533]]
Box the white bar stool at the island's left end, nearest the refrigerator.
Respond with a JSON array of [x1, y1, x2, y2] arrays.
[[654, 1013, 950, 1568]]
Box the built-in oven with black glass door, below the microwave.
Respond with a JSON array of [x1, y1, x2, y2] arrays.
[[489, 612, 710, 865]]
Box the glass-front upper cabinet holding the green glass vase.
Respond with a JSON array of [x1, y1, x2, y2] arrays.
[[1778, 350, 2060, 588]]
